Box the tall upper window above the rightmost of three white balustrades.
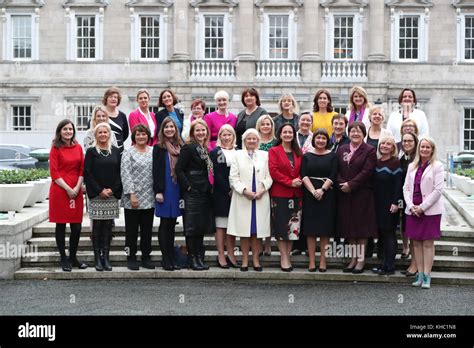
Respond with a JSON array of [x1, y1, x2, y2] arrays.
[[333, 16, 354, 59]]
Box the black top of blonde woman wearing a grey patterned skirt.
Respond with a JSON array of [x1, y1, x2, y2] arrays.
[[84, 146, 122, 199]]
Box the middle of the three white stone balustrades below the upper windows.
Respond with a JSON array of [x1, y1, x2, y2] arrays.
[[255, 60, 301, 80]]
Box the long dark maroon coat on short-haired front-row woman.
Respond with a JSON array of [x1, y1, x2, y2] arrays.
[[337, 143, 377, 239]]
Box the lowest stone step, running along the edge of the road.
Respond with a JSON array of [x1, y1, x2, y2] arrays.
[[15, 266, 474, 291]]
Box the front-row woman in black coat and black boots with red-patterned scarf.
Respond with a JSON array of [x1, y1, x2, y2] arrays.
[[176, 120, 215, 271]]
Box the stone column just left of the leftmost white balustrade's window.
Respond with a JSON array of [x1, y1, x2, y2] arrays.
[[171, 1, 190, 60]]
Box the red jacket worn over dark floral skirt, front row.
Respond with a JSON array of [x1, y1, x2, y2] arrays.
[[268, 145, 303, 198]]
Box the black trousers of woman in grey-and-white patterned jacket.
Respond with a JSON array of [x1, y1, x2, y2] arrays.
[[124, 208, 155, 259]]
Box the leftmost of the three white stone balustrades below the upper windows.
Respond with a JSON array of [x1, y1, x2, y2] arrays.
[[190, 60, 235, 80]]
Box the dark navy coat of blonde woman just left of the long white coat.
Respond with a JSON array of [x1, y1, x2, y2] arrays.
[[210, 146, 232, 217]]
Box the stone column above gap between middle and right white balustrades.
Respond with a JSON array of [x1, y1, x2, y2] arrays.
[[298, 0, 324, 60]]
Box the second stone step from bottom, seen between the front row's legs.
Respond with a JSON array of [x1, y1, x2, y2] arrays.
[[21, 250, 474, 272]]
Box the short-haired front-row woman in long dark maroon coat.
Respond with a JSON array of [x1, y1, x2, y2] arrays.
[[337, 121, 377, 274]]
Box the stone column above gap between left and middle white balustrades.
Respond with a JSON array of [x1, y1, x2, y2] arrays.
[[237, 0, 256, 60]]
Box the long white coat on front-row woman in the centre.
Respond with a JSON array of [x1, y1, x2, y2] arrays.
[[227, 150, 273, 238]]
